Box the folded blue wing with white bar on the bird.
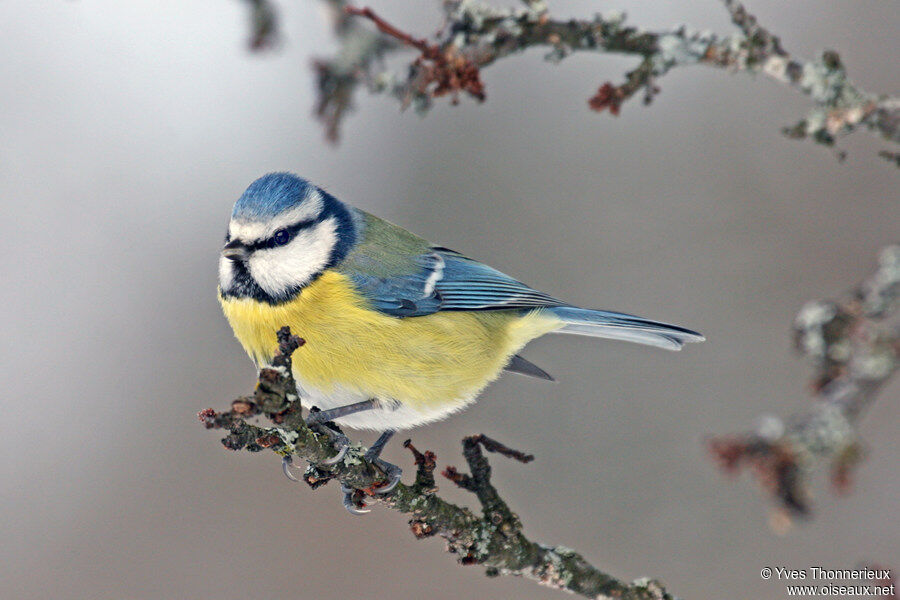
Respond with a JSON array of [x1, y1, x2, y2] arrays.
[[351, 248, 564, 317]]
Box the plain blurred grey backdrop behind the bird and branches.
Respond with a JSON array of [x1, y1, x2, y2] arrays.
[[0, 0, 900, 600]]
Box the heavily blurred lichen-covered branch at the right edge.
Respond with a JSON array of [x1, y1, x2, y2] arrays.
[[709, 245, 900, 516]]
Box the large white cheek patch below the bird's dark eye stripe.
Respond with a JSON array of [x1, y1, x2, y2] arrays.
[[249, 219, 337, 297]]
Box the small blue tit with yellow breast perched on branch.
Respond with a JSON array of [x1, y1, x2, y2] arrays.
[[218, 172, 704, 512]]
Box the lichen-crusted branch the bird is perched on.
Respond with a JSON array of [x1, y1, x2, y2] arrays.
[[199, 327, 674, 600]]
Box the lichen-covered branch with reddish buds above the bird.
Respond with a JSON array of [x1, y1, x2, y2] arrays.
[[243, 0, 900, 160]]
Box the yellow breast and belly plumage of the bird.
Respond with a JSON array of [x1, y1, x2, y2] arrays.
[[220, 271, 561, 410]]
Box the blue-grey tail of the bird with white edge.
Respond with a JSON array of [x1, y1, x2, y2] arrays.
[[550, 306, 706, 350]]
